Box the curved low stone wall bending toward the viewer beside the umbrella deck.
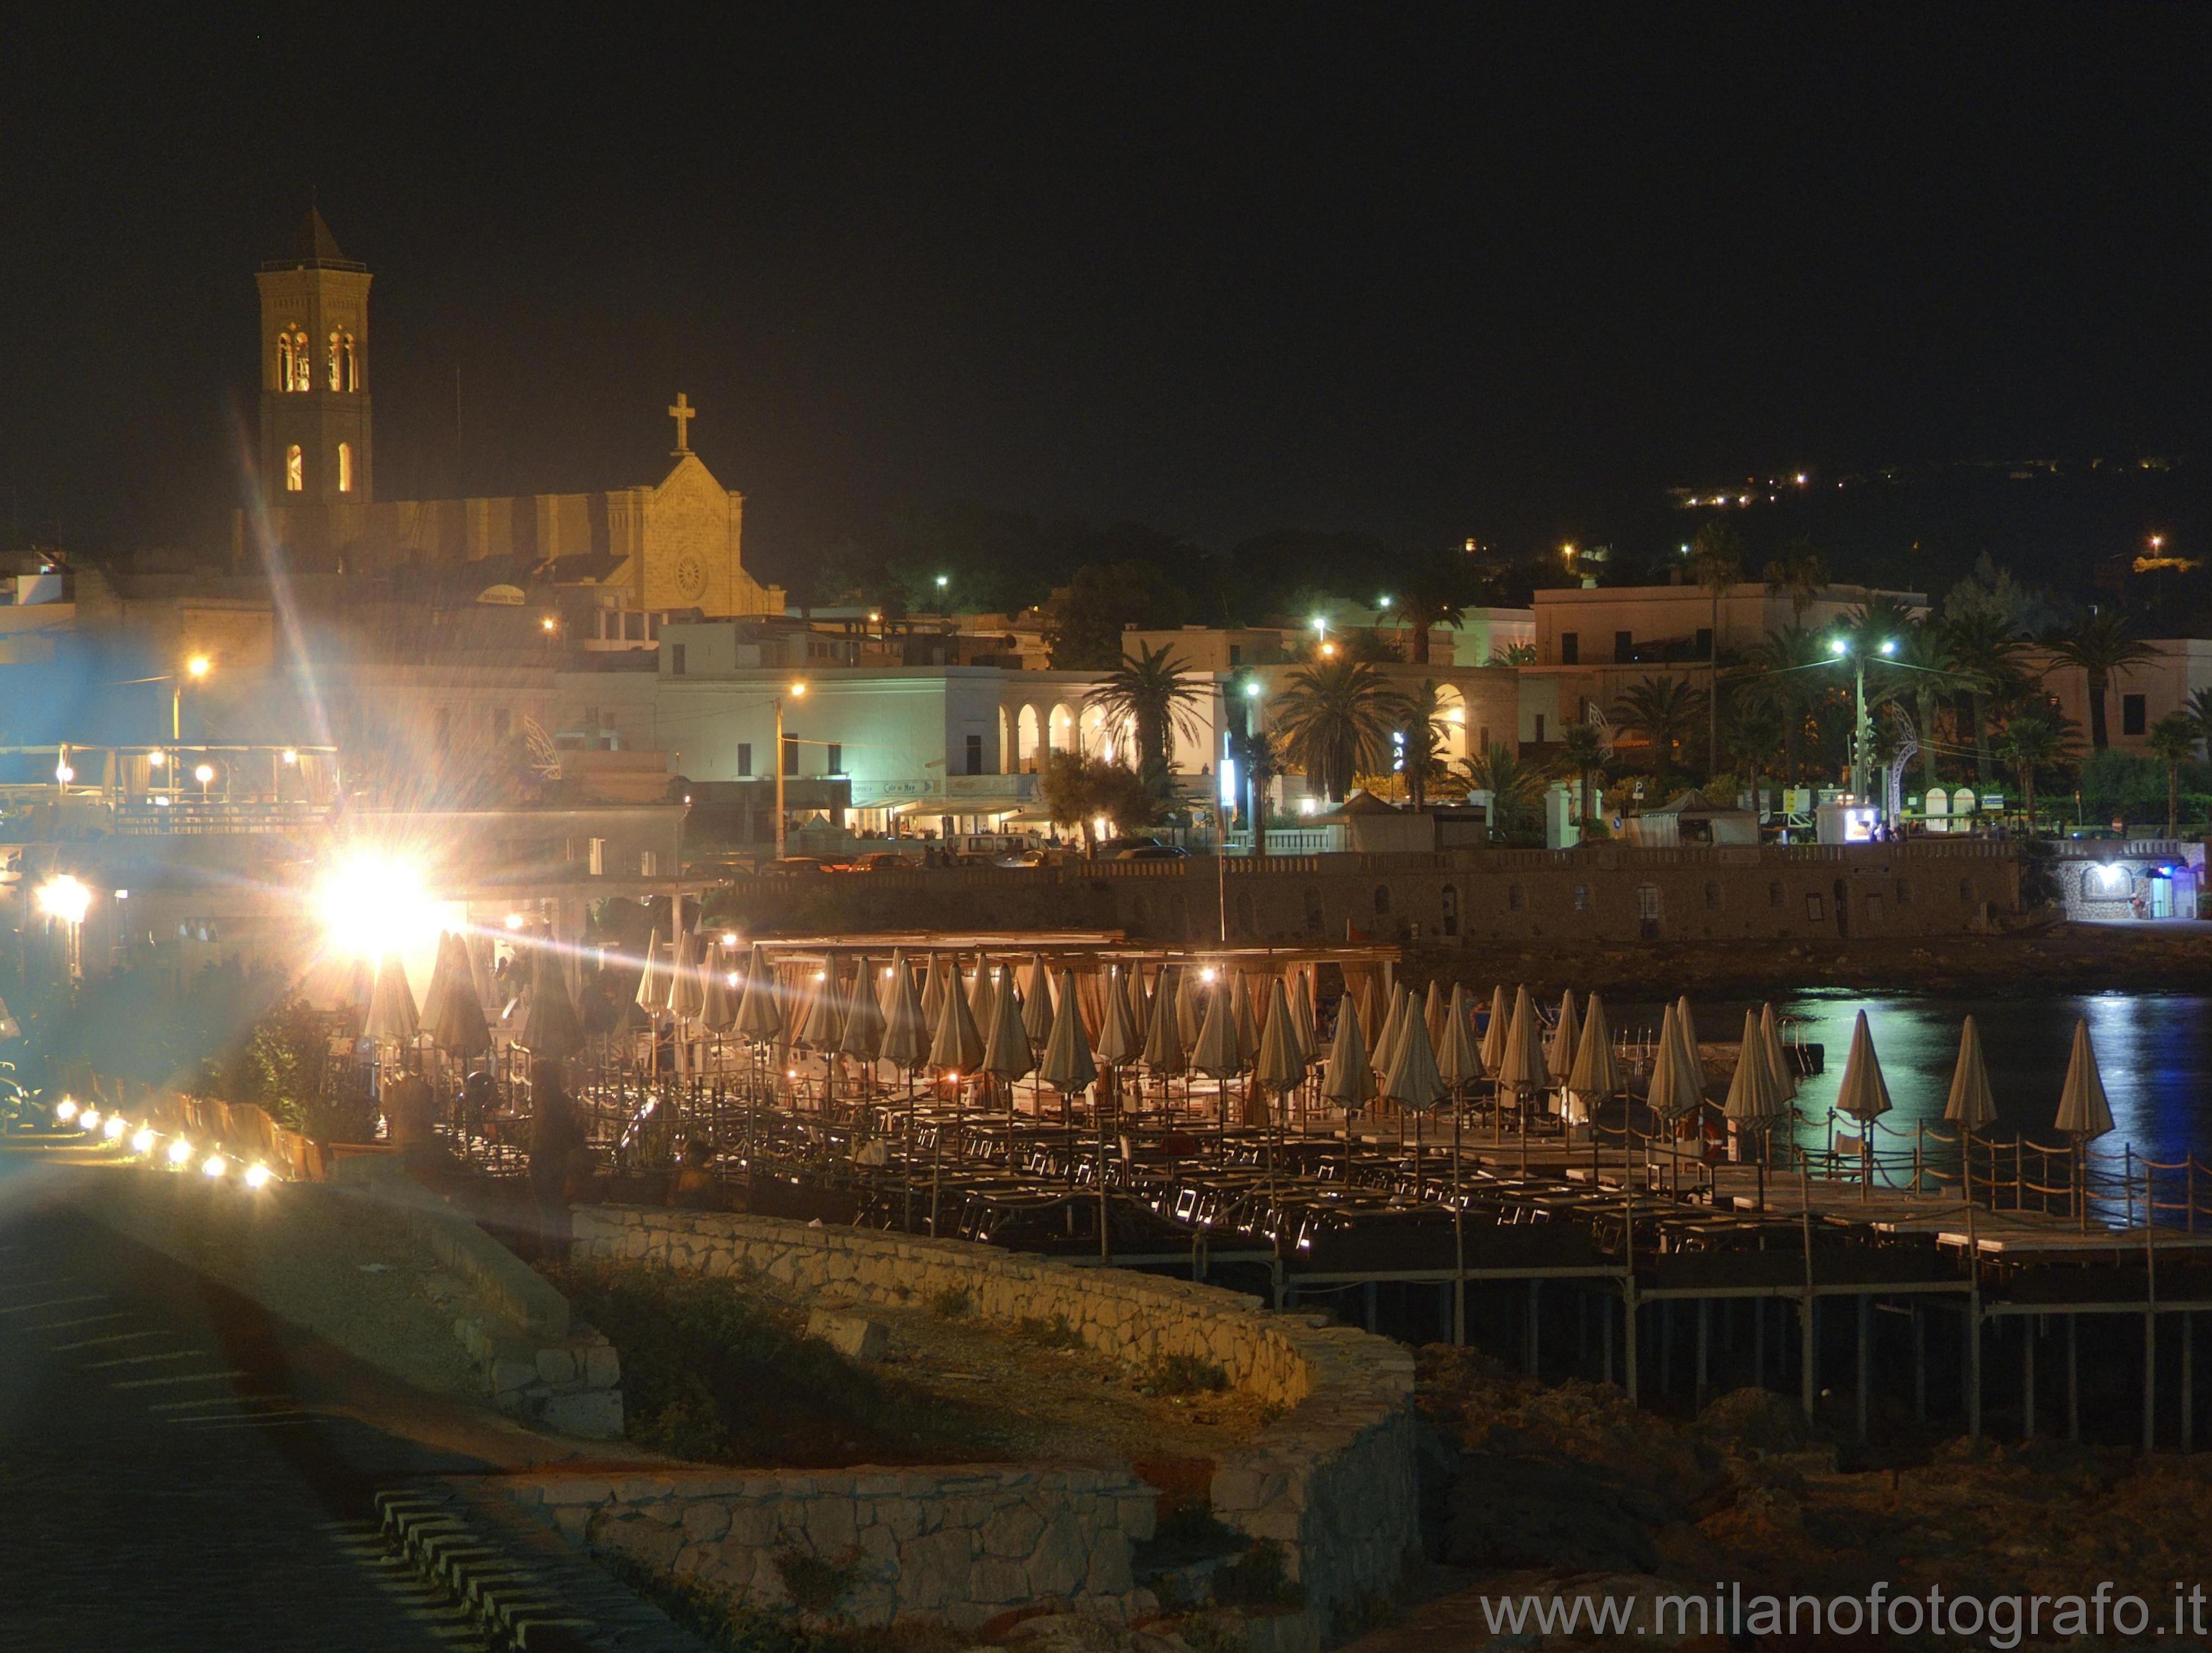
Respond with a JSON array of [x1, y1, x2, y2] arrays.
[[557, 1206, 1418, 1611]]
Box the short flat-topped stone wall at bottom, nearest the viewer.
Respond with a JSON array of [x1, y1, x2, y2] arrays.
[[496, 1465, 1157, 1629]]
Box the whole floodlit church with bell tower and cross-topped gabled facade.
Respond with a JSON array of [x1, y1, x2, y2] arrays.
[[232, 210, 783, 619]]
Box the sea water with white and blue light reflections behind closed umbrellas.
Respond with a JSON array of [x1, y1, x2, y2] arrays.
[[1608, 989, 2212, 1159]]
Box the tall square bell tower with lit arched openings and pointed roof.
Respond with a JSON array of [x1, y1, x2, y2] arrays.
[[254, 206, 376, 509]]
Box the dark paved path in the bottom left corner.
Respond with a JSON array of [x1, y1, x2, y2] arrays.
[[0, 1195, 480, 1653]]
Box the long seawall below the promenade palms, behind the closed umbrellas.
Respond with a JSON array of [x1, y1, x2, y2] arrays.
[[712, 838, 2019, 945]]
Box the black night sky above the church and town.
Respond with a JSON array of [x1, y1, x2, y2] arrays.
[[0, 4, 2212, 588]]
